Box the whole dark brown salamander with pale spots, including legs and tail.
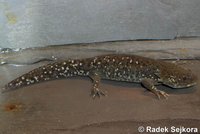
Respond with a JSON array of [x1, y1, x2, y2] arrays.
[[1, 54, 197, 98]]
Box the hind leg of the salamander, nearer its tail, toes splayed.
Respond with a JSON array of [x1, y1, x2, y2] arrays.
[[89, 73, 105, 98]]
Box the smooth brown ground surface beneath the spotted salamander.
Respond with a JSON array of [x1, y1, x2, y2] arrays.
[[0, 60, 200, 134]]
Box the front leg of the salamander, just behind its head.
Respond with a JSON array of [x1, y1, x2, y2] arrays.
[[142, 78, 169, 99]]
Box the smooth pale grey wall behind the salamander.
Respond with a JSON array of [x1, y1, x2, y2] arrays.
[[0, 0, 200, 48]]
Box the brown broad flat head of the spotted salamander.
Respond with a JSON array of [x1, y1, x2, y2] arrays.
[[161, 66, 198, 88]]
